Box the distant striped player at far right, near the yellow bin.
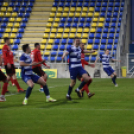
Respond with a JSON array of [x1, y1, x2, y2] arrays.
[[95, 49, 120, 87]]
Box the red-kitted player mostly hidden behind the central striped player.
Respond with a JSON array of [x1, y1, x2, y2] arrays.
[[80, 43, 95, 98]]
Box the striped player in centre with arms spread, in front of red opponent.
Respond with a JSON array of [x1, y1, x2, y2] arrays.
[[62, 37, 95, 100]]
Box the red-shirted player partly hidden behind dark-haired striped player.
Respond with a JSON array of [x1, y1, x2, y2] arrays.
[[31, 43, 50, 92]]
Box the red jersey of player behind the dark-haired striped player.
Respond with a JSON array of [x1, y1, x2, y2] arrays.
[[31, 49, 46, 68]]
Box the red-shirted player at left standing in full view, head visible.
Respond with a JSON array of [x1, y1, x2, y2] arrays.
[[2, 37, 25, 92]]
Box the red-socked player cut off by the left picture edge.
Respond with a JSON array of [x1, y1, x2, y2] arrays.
[[0, 55, 9, 102]]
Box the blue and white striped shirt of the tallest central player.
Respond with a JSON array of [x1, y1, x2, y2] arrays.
[[67, 45, 82, 69]]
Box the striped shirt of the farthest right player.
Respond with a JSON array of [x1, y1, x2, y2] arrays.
[[100, 54, 112, 68]]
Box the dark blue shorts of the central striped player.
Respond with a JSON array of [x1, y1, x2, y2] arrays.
[[69, 67, 87, 80]]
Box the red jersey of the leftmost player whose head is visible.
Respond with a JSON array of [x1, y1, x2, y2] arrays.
[[2, 44, 14, 65]]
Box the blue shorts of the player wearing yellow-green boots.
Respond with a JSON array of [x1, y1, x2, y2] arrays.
[[22, 74, 40, 83]]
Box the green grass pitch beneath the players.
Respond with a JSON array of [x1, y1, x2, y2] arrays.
[[0, 79, 134, 134]]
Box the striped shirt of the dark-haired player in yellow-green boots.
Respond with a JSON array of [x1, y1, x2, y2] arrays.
[[20, 53, 33, 76]]
